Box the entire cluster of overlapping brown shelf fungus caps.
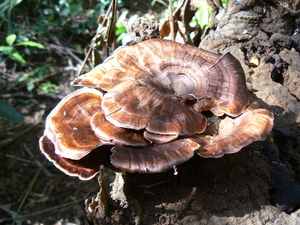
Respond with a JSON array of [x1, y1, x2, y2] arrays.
[[40, 39, 273, 179]]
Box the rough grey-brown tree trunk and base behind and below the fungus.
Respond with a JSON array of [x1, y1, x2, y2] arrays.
[[81, 0, 300, 224]]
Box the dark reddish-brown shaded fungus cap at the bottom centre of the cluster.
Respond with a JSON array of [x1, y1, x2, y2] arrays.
[[111, 139, 199, 173]]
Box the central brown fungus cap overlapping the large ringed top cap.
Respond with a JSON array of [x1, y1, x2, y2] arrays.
[[102, 80, 206, 135]]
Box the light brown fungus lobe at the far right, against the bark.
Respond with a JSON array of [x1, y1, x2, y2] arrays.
[[194, 109, 273, 158]]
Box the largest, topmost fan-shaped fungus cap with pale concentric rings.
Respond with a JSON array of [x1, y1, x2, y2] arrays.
[[72, 39, 249, 116]]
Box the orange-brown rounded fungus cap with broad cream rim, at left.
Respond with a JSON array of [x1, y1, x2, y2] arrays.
[[44, 88, 103, 159]]
